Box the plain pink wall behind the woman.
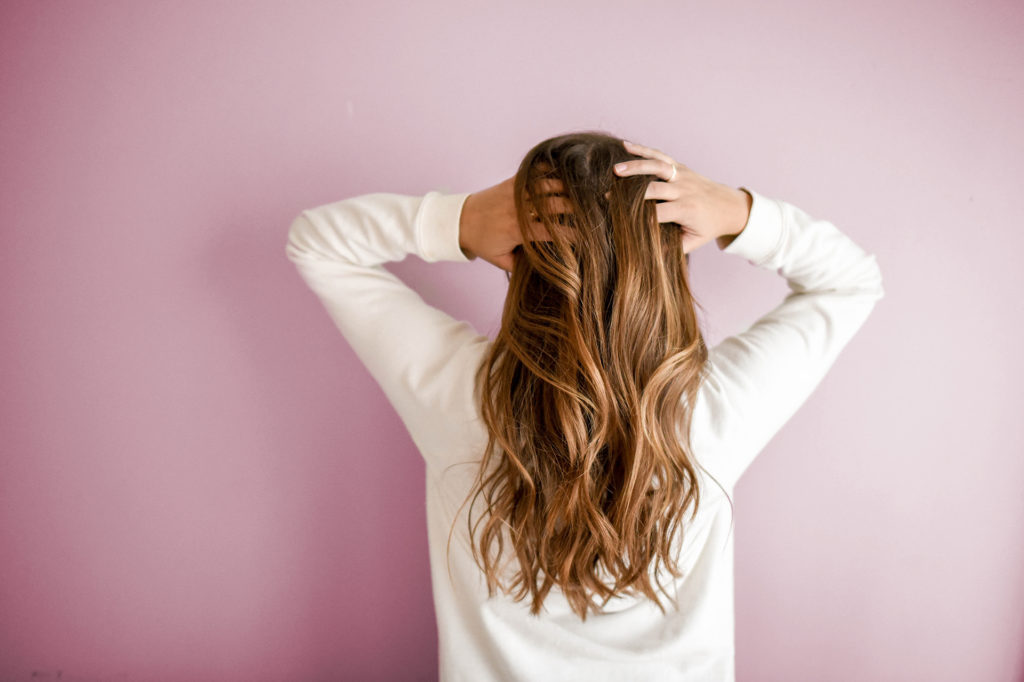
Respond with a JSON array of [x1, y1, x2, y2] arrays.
[[0, 0, 1024, 682]]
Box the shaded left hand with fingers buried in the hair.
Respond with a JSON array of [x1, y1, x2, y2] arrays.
[[459, 176, 565, 272]]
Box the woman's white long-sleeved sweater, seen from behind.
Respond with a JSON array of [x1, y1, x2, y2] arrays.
[[286, 187, 884, 682]]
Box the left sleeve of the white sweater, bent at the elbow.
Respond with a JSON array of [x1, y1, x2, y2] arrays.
[[285, 191, 489, 463]]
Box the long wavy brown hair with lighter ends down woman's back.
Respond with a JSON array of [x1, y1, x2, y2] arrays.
[[463, 131, 708, 620]]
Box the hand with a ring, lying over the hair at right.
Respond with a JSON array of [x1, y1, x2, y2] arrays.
[[614, 140, 754, 253]]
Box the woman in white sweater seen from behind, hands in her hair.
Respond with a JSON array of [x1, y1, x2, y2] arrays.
[[287, 131, 884, 682]]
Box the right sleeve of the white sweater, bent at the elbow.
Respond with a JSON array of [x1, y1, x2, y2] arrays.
[[691, 187, 885, 488]]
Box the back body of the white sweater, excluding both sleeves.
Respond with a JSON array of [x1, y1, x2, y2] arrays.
[[427, 444, 733, 681]]
